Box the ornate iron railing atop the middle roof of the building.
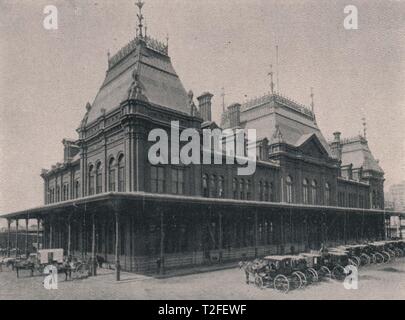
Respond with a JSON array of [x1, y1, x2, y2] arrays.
[[241, 93, 314, 118]]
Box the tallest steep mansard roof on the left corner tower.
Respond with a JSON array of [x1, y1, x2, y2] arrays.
[[87, 37, 190, 123]]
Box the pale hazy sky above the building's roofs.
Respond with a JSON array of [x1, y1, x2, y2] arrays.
[[0, 0, 405, 222]]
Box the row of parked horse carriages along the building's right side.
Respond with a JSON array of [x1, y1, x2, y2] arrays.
[[240, 240, 405, 293]]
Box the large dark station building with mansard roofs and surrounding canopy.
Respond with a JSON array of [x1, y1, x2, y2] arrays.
[[1, 3, 385, 271]]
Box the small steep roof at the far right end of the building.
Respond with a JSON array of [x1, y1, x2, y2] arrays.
[[341, 136, 384, 173]]
